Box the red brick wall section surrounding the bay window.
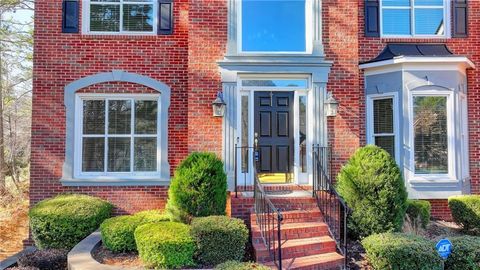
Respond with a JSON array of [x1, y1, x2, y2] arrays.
[[358, 1, 480, 219]]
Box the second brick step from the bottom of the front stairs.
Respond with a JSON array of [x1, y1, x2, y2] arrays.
[[253, 236, 336, 262]]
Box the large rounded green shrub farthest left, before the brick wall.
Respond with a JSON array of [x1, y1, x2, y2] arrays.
[[29, 194, 113, 250]]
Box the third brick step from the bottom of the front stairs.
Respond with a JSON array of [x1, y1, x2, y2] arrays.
[[251, 221, 329, 240]]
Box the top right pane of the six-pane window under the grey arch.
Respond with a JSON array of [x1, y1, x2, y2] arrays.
[[135, 100, 158, 134]]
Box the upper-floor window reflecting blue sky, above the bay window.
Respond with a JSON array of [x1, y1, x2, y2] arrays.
[[380, 0, 449, 37]]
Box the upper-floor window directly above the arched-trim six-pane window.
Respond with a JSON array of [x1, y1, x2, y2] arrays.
[[84, 0, 158, 34]]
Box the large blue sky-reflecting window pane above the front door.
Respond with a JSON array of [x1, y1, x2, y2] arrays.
[[242, 0, 306, 52]]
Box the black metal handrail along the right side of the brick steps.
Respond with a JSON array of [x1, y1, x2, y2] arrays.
[[312, 145, 350, 269]]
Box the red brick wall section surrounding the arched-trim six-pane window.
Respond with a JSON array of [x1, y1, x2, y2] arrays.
[[30, 0, 189, 213]]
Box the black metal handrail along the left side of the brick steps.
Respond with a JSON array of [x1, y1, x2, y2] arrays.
[[253, 166, 283, 269]]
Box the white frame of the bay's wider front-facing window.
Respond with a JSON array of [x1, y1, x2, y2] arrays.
[[408, 90, 458, 182]]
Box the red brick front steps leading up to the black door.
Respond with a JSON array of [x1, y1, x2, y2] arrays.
[[250, 196, 344, 270]]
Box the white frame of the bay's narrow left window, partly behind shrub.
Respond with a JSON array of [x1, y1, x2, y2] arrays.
[[367, 92, 401, 164]]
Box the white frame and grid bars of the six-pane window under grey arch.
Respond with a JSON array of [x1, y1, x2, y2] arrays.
[[74, 93, 162, 181]]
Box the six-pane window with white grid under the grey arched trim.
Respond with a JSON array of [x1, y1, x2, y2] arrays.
[[75, 95, 160, 179]]
